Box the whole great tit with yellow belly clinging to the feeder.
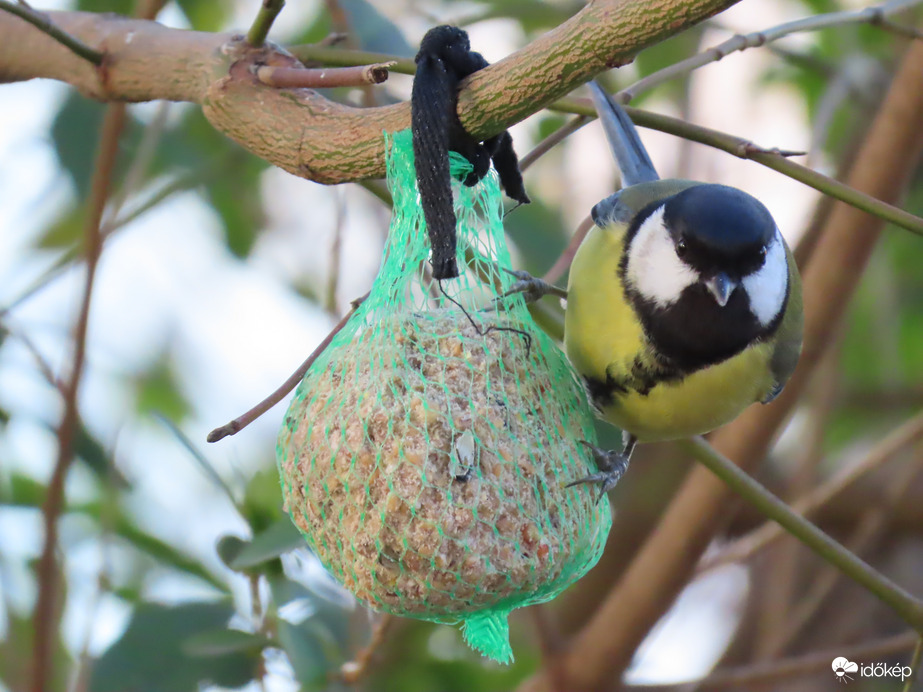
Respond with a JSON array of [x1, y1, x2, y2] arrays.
[[564, 82, 803, 497]]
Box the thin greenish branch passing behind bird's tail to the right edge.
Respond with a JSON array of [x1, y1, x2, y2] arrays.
[[554, 99, 923, 235]]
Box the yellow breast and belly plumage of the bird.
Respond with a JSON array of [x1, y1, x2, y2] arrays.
[[564, 226, 773, 442]]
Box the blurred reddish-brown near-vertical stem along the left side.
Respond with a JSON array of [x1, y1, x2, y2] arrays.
[[32, 104, 125, 692]]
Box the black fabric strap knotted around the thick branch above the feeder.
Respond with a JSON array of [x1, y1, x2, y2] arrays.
[[410, 26, 529, 279]]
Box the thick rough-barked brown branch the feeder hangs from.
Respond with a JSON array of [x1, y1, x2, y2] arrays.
[[0, 0, 737, 183]]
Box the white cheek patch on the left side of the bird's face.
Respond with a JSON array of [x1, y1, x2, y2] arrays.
[[625, 206, 699, 308]]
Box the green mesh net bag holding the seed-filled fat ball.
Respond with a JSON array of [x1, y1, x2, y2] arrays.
[[277, 130, 611, 662]]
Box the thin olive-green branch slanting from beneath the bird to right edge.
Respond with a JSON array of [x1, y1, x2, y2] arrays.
[[678, 437, 923, 632]]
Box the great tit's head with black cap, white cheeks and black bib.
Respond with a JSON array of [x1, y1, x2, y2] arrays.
[[620, 185, 789, 372]]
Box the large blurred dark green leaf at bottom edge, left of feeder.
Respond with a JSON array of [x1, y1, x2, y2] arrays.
[[89, 601, 261, 692]]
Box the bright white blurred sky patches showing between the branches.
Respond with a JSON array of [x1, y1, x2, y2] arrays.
[[0, 0, 815, 681]]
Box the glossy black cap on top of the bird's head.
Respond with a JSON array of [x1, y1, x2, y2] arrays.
[[663, 185, 776, 281]]
